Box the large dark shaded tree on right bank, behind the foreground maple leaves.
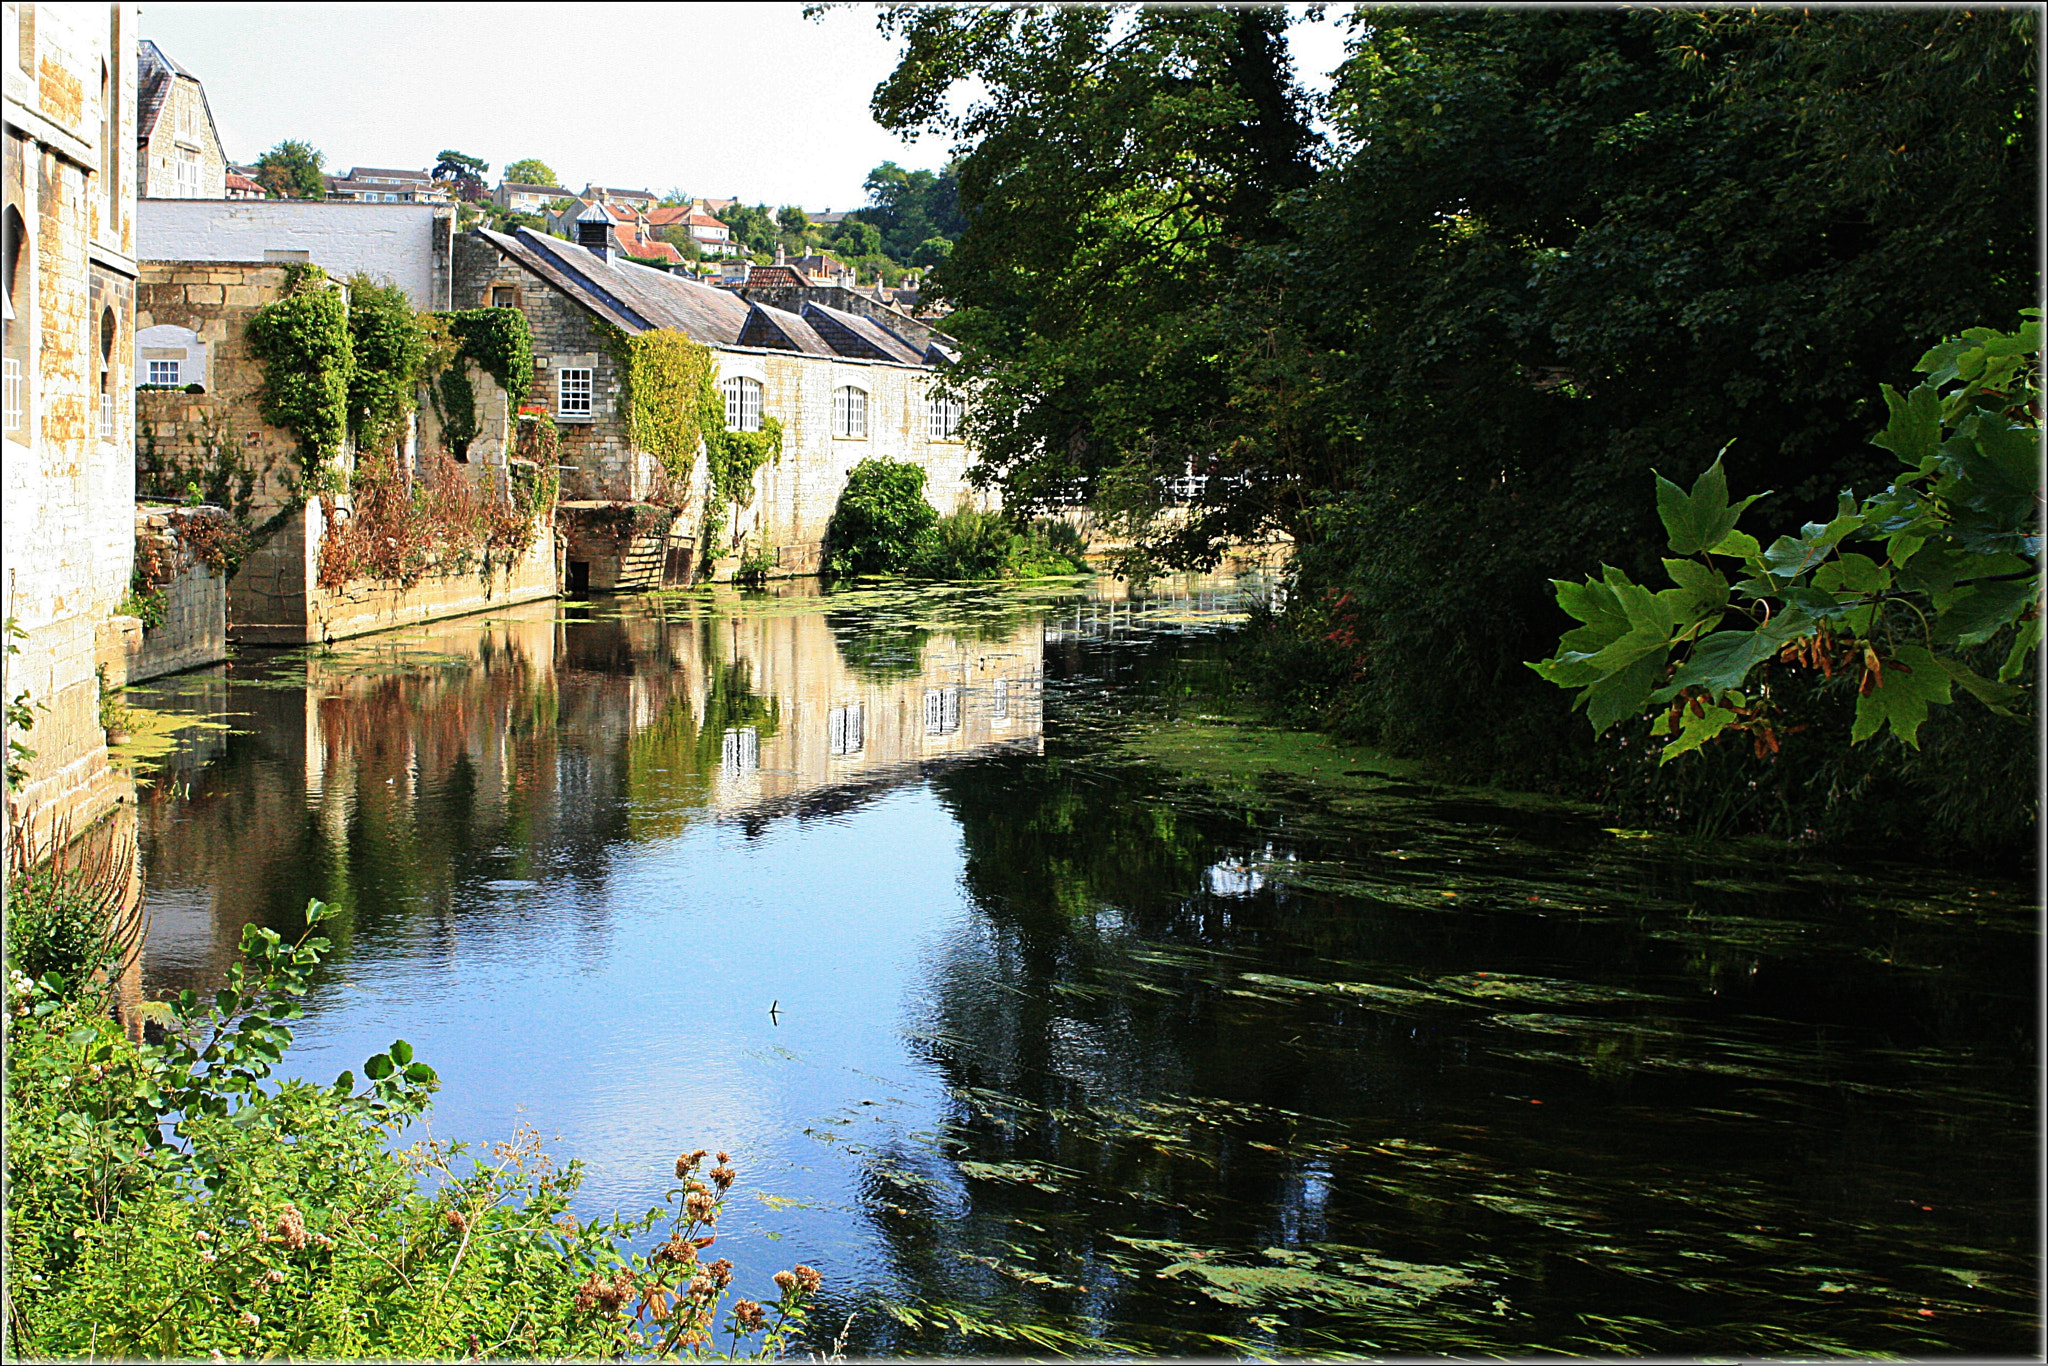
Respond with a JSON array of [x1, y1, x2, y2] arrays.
[[1262, 10, 2038, 782]]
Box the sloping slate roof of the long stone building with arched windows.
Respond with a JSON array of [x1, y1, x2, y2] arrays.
[[473, 227, 926, 365]]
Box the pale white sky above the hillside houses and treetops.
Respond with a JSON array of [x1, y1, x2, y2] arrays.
[[139, 2, 1343, 211]]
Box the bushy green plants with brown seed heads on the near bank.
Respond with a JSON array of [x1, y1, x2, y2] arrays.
[[6, 850, 819, 1360]]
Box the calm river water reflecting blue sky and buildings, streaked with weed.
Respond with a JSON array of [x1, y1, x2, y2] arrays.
[[133, 580, 2042, 1356]]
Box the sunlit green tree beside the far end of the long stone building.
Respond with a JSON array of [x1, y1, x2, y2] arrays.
[[874, 6, 1317, 555]]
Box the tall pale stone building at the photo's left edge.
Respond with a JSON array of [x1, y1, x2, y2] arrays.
[[0, 0, 141, 829]]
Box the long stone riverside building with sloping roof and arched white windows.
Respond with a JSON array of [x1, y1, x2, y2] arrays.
[[455, 225, 983, 586]]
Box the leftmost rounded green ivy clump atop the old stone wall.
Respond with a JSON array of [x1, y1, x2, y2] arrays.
[[248, 264, 354, 487]]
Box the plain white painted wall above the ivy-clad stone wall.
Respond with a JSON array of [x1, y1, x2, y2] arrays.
[[135, 199, 451, 309]]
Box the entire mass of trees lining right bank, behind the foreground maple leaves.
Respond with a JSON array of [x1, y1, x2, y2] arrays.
[[874, 6, 2040, 850]]
